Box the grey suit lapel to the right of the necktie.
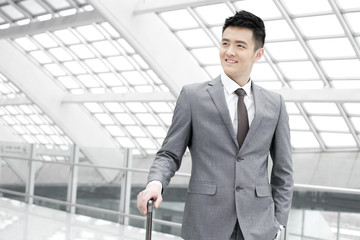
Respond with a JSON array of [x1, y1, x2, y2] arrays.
[[241, 82, 266, 149]]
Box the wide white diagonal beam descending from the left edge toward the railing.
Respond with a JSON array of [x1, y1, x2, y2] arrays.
[[0, 39, 125, 181]]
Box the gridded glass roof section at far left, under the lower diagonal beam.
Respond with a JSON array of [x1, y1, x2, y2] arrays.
[[0, 73, 72, 150]]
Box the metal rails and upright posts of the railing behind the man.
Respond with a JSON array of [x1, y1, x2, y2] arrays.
[[0, 148, 360, 239]]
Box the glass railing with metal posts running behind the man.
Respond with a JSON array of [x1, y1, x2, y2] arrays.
[[0, 145, 360, 240]]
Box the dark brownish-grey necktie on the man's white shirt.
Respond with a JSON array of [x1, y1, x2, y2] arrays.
[[235, 88, 249, 148]]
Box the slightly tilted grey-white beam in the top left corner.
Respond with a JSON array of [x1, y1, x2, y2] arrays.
[[0, 10, 104, 39]]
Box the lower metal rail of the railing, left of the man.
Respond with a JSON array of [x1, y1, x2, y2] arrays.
[[0, 188, 181, 228]]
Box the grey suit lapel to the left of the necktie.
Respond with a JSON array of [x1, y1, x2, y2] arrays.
[[208, 76, 238, 145]]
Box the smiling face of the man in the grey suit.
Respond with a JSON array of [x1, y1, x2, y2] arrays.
[[220, 26, 264, 81]]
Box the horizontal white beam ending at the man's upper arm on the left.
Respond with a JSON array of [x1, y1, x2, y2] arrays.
[[62, 92, 176, 104]]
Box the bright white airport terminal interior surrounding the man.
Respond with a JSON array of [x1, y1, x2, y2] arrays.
[[0, 0, 360, 240]]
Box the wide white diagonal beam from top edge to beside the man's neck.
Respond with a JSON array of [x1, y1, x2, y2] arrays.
[[89, 0, 207, 96]]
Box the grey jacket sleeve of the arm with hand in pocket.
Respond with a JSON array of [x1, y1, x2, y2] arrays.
[[270, 96, 294, 226]]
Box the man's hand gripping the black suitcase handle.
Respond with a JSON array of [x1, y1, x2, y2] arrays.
[[137, 181, 162, 215]]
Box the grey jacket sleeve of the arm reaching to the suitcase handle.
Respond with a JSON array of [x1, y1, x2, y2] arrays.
[[148, 87, 192, 190]]
